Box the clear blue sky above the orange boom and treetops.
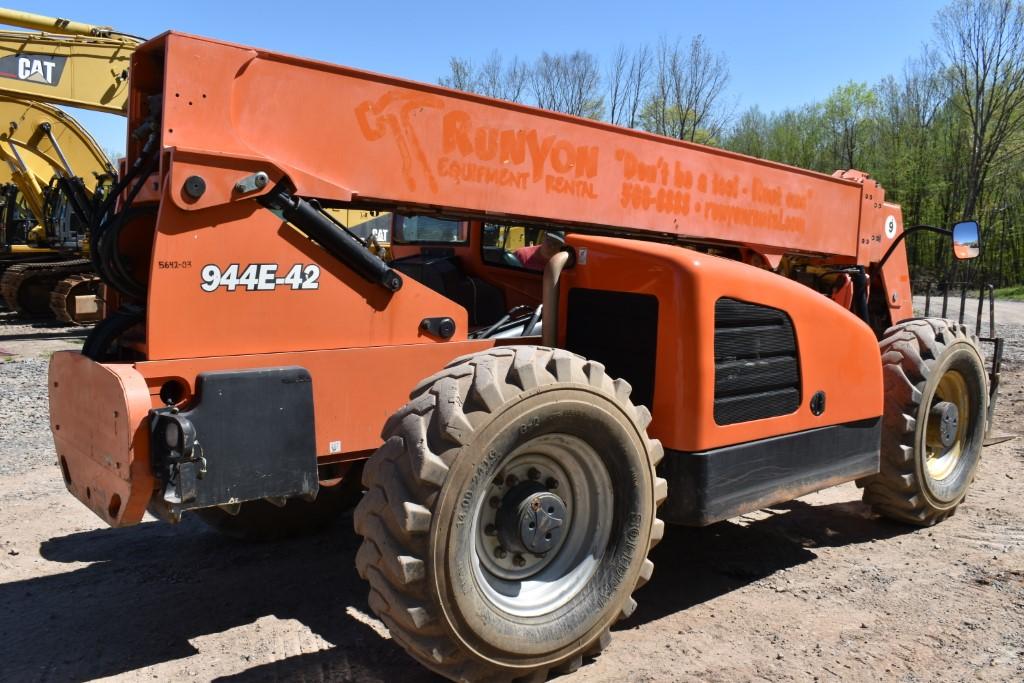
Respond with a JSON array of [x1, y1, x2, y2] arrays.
[[36, 0, 947, 153]]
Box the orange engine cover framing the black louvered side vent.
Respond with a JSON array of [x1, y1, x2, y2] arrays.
[[559, 234, 883, 453]]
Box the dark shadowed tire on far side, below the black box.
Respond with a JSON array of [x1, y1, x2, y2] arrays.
[[195, 468, 362, 541]]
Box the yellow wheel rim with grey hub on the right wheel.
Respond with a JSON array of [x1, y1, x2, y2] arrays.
[[925, 370, 973, 481]]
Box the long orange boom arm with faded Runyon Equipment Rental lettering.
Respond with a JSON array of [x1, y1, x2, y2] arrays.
[[129, 33, 897, 259]]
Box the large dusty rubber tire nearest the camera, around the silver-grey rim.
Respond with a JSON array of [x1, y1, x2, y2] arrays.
[[354, 346, 668, 681]]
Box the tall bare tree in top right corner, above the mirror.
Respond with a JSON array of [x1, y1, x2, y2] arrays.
[[935, 0, 1024, 216]]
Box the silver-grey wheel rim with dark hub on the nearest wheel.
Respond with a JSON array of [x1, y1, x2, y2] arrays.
[[472, 434, 614, 616]]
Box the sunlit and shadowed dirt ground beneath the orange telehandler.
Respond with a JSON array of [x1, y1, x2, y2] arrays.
[[0, 304, 1024, 683]]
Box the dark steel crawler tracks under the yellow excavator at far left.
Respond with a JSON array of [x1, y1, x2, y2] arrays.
[[0, 259, 98, 324]]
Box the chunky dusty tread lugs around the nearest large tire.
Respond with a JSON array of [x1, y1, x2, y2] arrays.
[[353, 346, 667, 681]]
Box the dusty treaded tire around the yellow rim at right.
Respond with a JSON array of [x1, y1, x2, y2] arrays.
[[858, 318, 988, 526]]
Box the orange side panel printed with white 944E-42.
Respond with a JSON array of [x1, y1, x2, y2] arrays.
[[146, 187, 468, 359]]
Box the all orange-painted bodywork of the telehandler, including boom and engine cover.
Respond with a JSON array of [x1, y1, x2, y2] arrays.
[[50, 33, 910, 525]]
